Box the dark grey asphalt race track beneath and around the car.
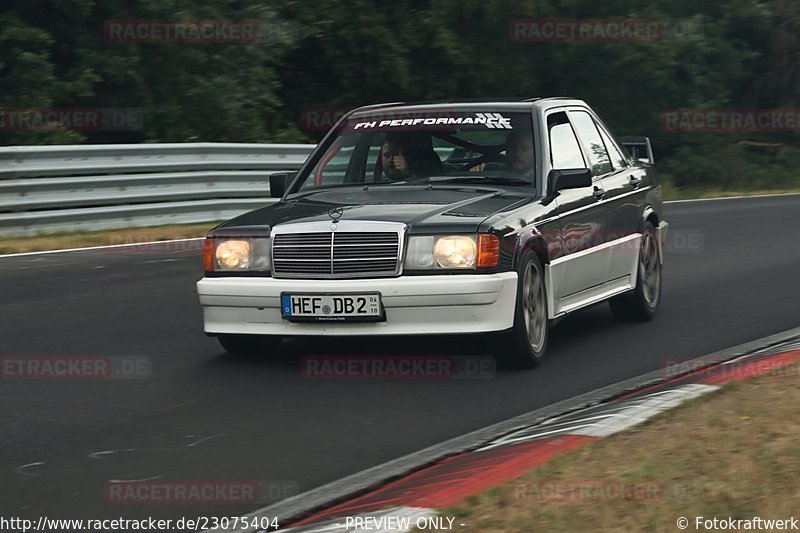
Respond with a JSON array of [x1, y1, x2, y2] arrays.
[[0, 196, 800, 519]]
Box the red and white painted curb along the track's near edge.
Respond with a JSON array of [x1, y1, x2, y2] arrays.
[[276, 344, 800, 533]]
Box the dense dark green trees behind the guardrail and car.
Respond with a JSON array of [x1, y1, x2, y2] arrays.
[[0, 0, 800, 188]]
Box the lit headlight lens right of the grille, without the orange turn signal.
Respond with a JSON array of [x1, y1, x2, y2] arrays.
[[405, 235, 478, 270]]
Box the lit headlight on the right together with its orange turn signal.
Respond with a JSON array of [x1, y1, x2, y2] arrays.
[[405, 234, 500, 270]]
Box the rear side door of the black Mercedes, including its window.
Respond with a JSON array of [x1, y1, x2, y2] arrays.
[[569, 109, 641, 283]]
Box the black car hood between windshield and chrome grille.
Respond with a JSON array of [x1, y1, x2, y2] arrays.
[[215, 185, 534, 233]]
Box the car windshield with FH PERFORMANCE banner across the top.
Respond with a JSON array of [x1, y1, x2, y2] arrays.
[[293, 111, 535, 192]]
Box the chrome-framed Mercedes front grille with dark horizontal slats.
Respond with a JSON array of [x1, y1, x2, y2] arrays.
[[272, 231, 400, 277]]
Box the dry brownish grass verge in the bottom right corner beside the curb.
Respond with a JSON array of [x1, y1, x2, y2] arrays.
[[428, 366, 800, 532]]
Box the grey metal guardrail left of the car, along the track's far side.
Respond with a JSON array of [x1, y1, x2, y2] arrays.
[[0, 143, 314, 236]]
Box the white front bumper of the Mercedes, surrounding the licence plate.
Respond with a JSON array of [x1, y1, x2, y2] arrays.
[[197, 272, 517, 335]]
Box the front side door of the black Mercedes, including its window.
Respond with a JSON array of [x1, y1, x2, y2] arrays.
[[546, 110, 605, 314]]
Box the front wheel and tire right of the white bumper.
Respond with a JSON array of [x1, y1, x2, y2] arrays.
[[495, 251, 550, 368]]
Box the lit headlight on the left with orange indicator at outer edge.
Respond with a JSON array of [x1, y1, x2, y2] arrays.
[[203, 237, 269, 272]]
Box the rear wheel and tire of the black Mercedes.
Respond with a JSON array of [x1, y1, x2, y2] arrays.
[[609, 220, 662, 322]]
